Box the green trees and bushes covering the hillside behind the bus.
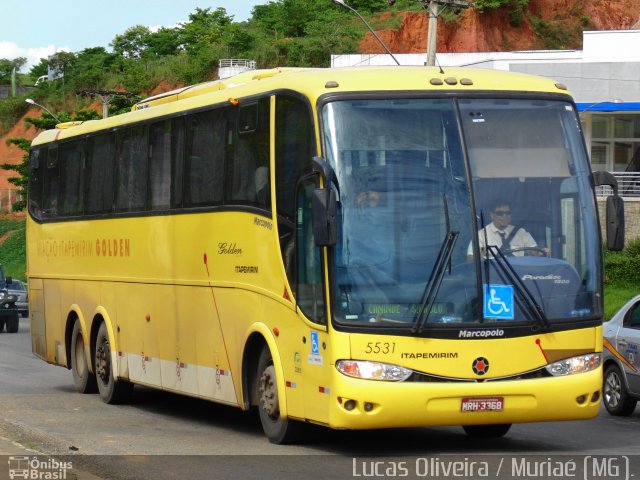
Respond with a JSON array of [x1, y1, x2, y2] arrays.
[[0, 0, 600, 133]]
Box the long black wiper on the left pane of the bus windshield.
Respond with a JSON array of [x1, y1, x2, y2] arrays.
[[411, 195, 460, 334]]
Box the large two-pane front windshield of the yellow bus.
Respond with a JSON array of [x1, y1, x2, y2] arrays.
[[322, 98, 601, 332]]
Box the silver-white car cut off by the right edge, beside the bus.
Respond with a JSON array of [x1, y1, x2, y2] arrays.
[[602, 295, 640, 416]]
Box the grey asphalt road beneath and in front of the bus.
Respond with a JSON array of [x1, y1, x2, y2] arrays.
[[0, 319, 640, 480]]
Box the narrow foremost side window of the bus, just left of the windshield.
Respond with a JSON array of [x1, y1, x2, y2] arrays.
[[296, 175, 326, 324]]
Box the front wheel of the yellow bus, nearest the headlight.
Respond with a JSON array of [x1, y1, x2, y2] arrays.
[[256, 347, 301, 445]]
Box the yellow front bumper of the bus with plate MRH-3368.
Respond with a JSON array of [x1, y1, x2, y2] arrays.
[[330, 367, 602, 429]]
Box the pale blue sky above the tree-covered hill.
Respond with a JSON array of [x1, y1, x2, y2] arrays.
[[0, 0, 269, 73]]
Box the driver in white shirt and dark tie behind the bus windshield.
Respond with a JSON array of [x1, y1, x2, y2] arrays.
[[467, 199, 549, 257]]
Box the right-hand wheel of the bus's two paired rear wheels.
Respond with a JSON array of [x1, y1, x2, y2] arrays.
[[94, 322, 133, 405]]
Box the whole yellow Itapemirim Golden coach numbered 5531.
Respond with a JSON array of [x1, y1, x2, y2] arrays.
[[27, 67, 621, 443]]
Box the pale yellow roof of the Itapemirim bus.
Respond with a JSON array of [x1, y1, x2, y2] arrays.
[[33, 66, 569, 145]]
